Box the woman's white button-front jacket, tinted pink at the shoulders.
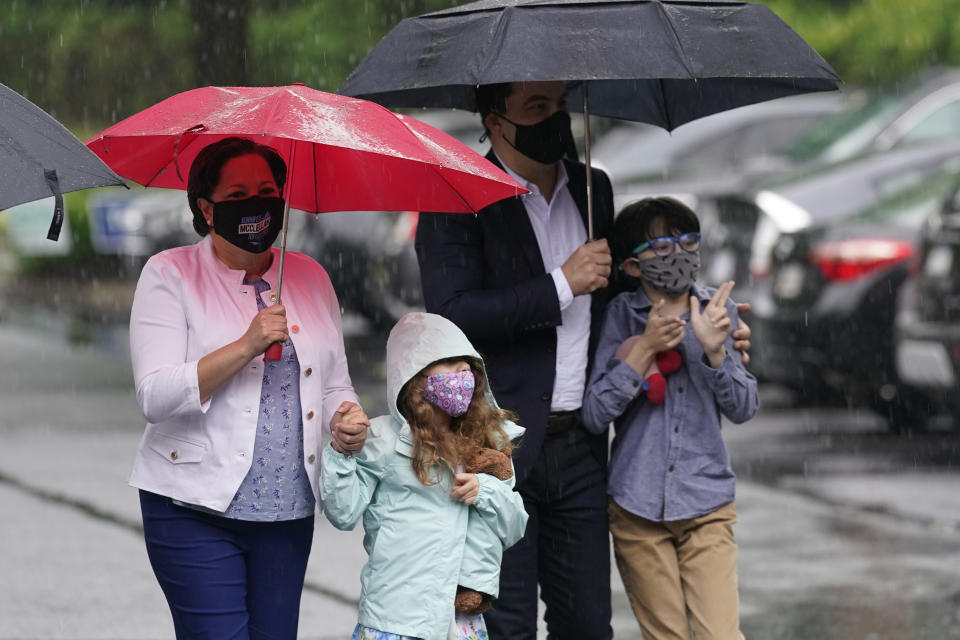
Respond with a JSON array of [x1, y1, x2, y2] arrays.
[[130, 236, 357, 511]]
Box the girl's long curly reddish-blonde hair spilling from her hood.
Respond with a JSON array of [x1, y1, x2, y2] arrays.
[[397, 356, 516, 485]]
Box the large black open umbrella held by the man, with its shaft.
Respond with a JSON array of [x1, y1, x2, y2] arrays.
[[340, 0, 840, 237]]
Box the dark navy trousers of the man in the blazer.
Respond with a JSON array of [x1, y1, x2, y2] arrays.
[[483, 425, 613, 640]]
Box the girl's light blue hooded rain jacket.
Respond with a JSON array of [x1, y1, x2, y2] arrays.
[[320, 313, 527, 640]]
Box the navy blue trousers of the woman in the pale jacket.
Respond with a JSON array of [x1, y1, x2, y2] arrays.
[[140, 491, 313, 640]]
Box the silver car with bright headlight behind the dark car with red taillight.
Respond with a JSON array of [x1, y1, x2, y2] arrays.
[[699, 71, 960, 299]]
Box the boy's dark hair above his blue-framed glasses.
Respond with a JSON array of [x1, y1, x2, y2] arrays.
[[610, 197, 700, 265]]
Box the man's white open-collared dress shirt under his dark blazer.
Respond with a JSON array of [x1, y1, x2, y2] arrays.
[[497, 157, 590, 411]]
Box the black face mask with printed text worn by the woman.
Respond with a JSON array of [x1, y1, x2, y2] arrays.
[[213, 196, 284, 253]]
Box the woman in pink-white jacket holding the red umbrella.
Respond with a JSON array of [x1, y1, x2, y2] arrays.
[[130, 138, 369, 638]]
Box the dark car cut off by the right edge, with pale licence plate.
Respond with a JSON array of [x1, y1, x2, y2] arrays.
[[894, 182, 960, 425]]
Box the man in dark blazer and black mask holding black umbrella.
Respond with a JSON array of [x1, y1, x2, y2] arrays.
[[416, 82, 749, 640]]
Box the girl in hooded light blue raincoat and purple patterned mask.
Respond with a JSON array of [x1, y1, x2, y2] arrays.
[[321, 313, 527, 640]]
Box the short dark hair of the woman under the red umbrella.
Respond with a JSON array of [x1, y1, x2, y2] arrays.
[[187, 137, 287, 237]]
